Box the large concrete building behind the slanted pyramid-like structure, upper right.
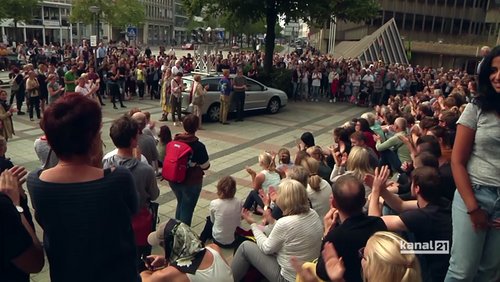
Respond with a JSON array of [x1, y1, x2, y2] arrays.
[[317, 0, 500, 70]]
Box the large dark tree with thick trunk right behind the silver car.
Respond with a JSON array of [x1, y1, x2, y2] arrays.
[[183, 0, 379, 73]]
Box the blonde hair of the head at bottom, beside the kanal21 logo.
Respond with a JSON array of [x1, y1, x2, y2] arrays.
[[363, 231, 422, 282]]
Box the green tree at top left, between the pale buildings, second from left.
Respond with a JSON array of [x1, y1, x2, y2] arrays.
[[71, 0, 145, 27]]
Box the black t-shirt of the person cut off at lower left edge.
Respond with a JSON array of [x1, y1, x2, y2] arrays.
[[0, 193, 33, 282]]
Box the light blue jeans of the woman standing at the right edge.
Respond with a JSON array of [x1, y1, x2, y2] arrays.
[[445, 185, 500, 282]]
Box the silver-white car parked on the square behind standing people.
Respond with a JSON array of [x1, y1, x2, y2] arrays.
[[181, 74, 288, 121]]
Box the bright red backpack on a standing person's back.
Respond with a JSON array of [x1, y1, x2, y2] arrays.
[[161, 141, 193, 183]]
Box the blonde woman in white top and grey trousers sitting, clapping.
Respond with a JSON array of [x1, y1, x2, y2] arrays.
[[231, 179, 322, 281]]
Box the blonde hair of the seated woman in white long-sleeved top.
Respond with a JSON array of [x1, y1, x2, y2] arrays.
[[276, 179, 310, 216]]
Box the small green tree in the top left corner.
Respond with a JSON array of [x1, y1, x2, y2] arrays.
[[0, 0, 40, 40]]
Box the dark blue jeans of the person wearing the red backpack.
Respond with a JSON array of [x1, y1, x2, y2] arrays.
[[169, 182, 202, 226]]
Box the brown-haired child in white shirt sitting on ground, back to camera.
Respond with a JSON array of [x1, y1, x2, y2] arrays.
[[200, 176, 242, 248]]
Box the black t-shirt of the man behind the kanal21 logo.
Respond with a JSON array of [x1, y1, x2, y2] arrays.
[[399, 198, 452, 281]]
